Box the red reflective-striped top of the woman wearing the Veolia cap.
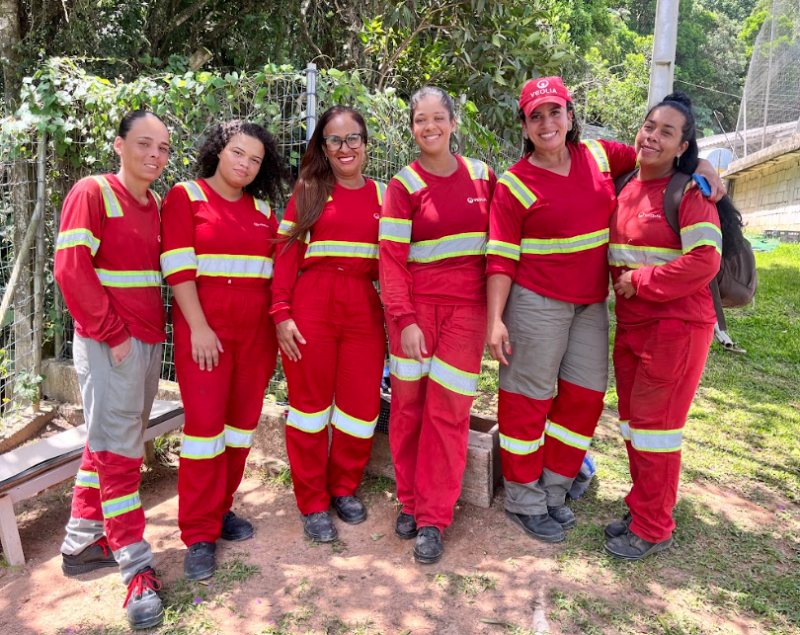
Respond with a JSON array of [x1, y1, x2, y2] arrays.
[[487, 141, 636, 304]]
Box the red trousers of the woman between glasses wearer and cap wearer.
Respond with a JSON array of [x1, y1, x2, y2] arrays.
[[389, 302, 486, 531]]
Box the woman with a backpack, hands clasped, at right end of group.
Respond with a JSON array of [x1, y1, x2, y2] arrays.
[[605, 93, 741, 560]]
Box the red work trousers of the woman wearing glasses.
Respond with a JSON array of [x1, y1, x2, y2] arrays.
[[283, 268, 386, 515]]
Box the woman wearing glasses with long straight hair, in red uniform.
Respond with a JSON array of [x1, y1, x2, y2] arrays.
[[270, 106, 386, 542]]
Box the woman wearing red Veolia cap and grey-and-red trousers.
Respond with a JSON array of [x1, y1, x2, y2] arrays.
[[487, 77, 721, 542]]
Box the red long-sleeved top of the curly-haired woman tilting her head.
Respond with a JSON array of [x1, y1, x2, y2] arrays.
[[161, 179, 278, 290]]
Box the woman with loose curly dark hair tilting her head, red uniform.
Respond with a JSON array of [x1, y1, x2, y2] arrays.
[[161, 121, 288, 580]]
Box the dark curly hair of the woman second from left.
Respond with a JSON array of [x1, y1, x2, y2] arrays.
[[195, 119, 291, 204]]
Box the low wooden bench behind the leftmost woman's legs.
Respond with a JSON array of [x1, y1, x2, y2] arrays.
[[0, 401, 183, 566]]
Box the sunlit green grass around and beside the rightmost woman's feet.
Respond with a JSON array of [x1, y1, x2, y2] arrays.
[[480, 244, 800, 635]]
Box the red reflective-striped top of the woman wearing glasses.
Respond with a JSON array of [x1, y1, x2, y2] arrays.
[[270, 179, 386, 324]]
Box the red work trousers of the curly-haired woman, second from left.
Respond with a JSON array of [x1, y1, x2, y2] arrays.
[[174, 283, 278, 546]]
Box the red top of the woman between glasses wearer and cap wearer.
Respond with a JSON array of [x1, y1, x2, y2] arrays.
[[380, 157, 497, 329]]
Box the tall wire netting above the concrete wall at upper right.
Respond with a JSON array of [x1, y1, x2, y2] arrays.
[[734, 0, 800, 158]]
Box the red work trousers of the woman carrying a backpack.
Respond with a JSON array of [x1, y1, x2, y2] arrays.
[[614, 319, 714, 542]]
